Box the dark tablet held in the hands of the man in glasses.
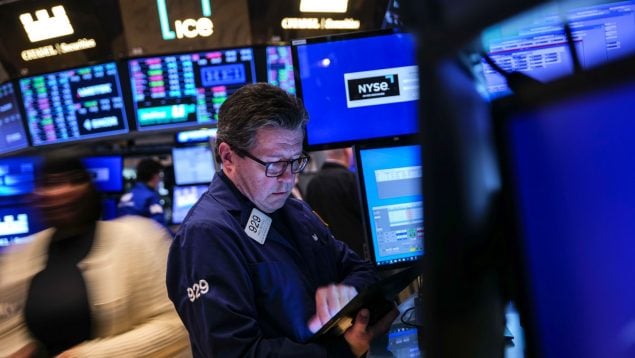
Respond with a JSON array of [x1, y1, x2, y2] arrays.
[[311, 263, 423, 342]]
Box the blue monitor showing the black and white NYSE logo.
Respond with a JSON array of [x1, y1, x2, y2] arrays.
[[292, 30, 419, 150]]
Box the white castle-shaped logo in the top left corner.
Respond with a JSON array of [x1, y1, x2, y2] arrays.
[[20, 5, 75, 42]]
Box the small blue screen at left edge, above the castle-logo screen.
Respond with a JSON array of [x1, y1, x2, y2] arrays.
[[0, 157, 39, 196]]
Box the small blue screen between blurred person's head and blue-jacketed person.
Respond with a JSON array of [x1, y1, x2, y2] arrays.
[[82, 155, 123, 192]]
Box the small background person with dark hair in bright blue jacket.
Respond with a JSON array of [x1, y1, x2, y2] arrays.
[[118, 158, 166, 226]]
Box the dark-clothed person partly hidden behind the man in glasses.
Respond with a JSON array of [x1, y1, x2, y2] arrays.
[[304, 148, 368, 257]]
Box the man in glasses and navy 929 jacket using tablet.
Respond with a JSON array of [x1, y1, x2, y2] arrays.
[[167, 83, 397, 357]]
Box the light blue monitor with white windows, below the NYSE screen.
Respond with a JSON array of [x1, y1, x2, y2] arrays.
[[355, 141, 424, 269]]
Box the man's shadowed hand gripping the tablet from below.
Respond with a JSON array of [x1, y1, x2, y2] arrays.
[[344, 307, 399, 357]]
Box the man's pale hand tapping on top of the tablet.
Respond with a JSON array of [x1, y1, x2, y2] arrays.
[[308, 284, 357, 333]]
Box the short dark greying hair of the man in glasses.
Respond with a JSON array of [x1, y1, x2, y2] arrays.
[[214, 83, 309, 163]]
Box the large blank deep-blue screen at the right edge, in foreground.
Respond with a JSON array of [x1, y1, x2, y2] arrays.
[[506, 79, 635, 358]]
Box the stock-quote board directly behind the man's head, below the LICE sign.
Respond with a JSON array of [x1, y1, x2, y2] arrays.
[[128, 48, 256, 131]]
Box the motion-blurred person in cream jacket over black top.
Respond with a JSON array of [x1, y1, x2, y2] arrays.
[[0, 155, 191, 357]]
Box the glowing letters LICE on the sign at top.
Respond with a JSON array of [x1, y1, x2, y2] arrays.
[[157, 0, 214, 40]]
